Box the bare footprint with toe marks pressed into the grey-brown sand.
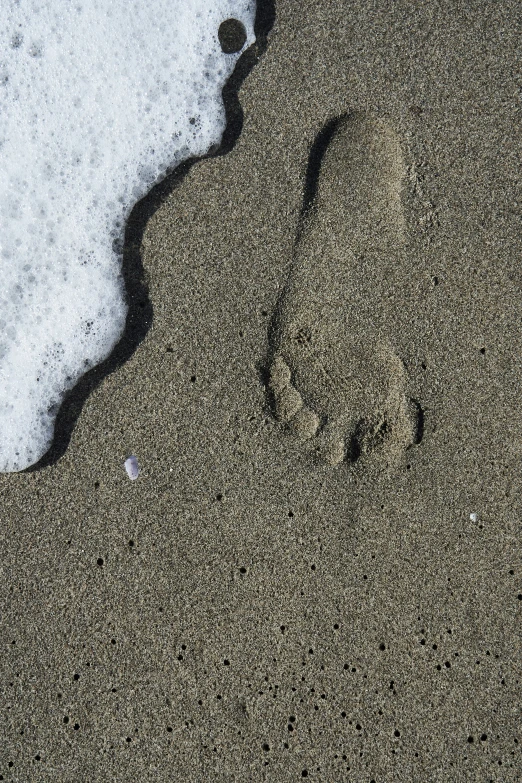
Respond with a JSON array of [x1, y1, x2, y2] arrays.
[[269, 113, 421, 465]]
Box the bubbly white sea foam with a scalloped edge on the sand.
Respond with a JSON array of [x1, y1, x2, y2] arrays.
[[0, 0, 255, 472]]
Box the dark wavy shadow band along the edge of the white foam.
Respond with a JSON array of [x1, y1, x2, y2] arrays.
[[27, 0, 275, 473]]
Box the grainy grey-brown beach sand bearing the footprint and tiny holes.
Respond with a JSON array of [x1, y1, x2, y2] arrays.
[[0, 0, 522, 783]]
